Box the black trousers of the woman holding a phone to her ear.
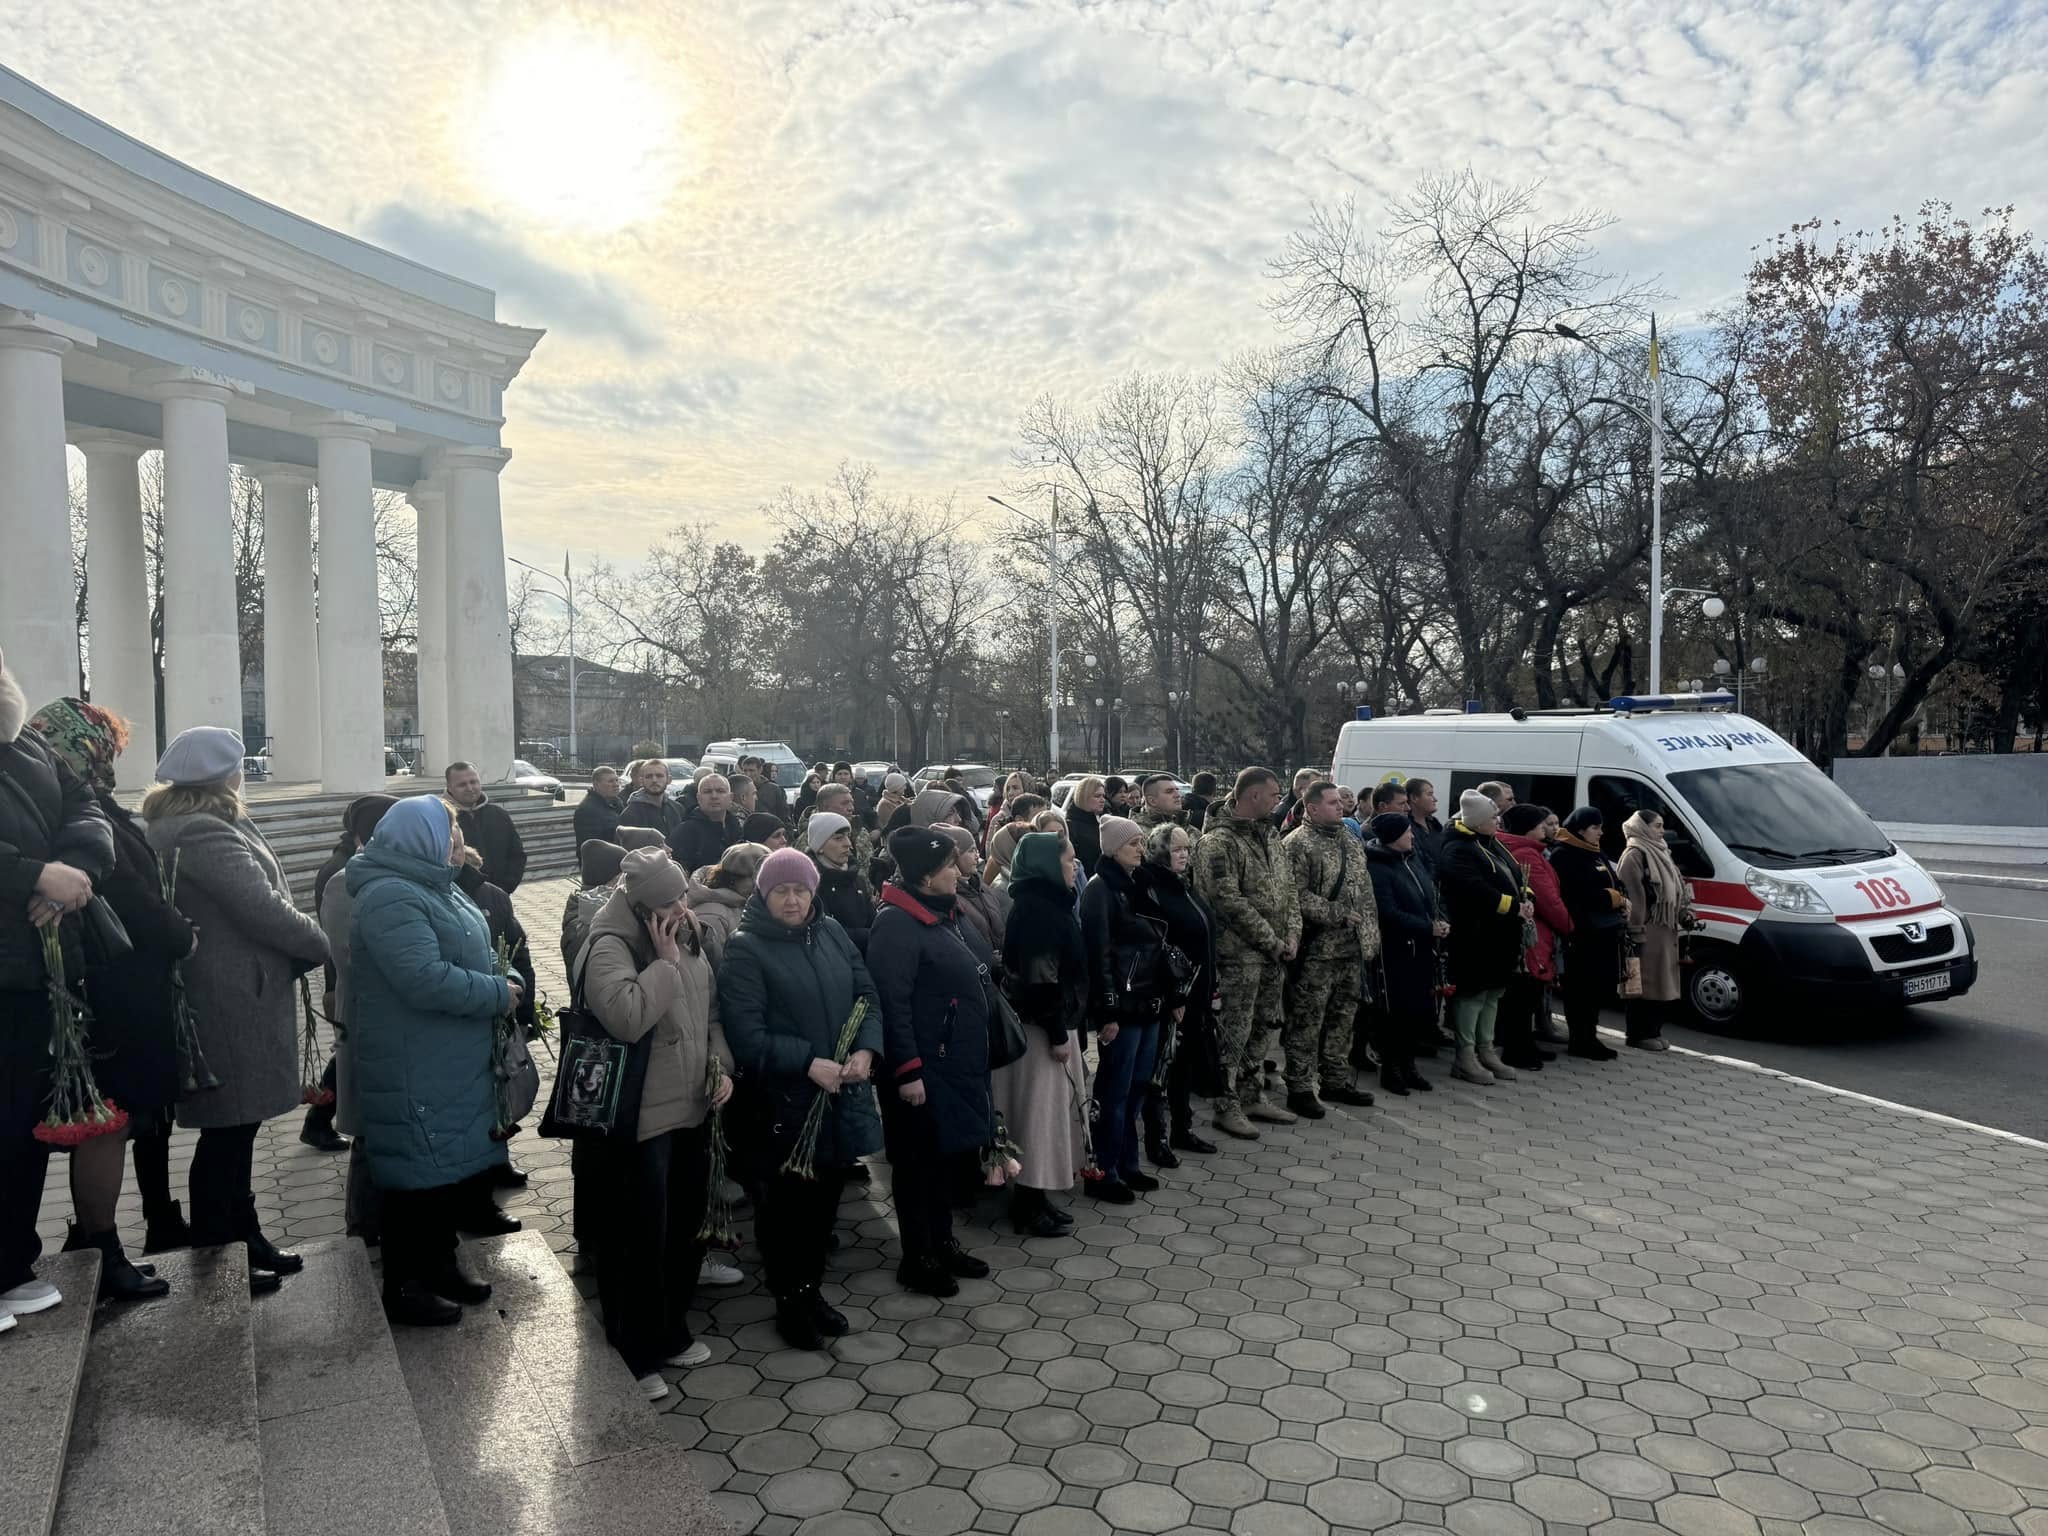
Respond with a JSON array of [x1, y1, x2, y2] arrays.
[[594, 1120, 711, 1376]]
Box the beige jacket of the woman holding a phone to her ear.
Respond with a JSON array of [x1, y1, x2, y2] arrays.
[[580, 891, 733, 1141]]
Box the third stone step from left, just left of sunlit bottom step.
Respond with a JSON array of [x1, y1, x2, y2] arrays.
[[254, 1237, 449, 1536]]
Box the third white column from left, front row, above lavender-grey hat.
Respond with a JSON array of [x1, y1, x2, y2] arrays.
[[139, 369, 252, 737]]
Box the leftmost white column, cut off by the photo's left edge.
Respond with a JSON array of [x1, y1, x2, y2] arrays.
[[0, 319, 78, 709]]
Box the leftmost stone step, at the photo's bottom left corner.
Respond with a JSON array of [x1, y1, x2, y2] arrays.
[[0, 1251, 100, 1536]]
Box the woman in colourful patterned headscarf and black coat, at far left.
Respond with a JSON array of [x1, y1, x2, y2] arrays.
[[29, 698, 184, 1300]]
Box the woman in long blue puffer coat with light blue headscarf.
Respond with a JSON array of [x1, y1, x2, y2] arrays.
[[346, 795, 522, 1325]]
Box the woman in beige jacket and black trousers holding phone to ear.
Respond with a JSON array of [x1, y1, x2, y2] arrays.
[[580, 848, 733, 1403]]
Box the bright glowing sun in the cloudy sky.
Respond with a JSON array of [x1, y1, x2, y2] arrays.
[[471, 23, 682, 229]]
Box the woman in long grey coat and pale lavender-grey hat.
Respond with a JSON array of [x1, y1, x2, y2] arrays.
[[141, 725, 328, 1290]]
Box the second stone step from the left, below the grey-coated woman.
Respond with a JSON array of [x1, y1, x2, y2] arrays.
[[53, 1245, 264, 1536]]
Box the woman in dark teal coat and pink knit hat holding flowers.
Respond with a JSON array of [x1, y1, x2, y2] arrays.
[[719, 834, 880, 1350]]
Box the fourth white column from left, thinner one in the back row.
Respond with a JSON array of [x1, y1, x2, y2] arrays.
[[250, 465, 322, 784]]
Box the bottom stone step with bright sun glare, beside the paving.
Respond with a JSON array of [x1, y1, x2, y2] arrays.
[[393, 1233, 731, 1536]]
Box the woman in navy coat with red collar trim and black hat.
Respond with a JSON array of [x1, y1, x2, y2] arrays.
[[868, 825, 995, 1296]]
